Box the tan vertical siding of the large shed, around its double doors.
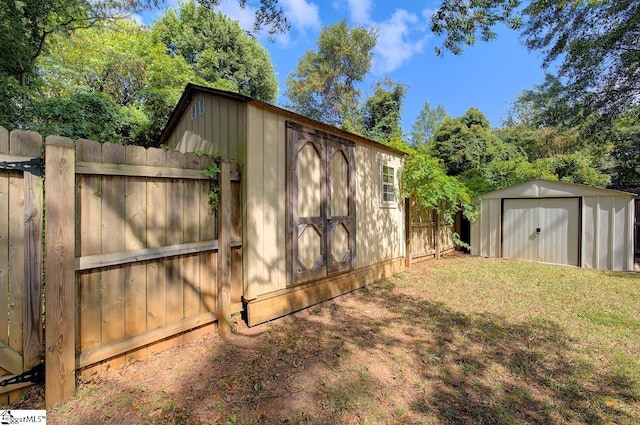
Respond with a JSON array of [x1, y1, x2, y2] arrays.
[[168, 94, 404, 299]]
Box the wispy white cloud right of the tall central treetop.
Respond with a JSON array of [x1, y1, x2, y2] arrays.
[[373, 9, 429, 74]]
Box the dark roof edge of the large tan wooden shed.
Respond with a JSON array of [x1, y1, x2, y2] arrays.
[[158, 83, 405, 156]]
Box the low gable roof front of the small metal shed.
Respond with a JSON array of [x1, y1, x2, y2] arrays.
[[481, 179, 634, 199]]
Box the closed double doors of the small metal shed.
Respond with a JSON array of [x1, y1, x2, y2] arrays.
[[502, 198, 580, 266]]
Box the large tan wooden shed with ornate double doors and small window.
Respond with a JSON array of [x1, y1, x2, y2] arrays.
[[160, 85, 405, 325]]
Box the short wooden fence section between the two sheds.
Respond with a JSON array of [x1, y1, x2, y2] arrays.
[[405, 199, 456, 266]]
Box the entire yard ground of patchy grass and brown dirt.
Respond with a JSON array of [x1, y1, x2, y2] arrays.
[[47, 253, 640, 425]]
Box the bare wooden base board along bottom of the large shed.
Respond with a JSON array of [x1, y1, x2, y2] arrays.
[[245, 257, 405, 326]]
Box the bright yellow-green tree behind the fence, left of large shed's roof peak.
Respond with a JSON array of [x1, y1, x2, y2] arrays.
[[32, 20, 197, 146]]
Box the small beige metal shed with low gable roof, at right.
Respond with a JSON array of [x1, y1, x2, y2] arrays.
[[471, 180, 634, 270]]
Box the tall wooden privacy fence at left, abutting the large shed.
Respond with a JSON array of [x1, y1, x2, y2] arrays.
[[0, 128, 242, 406]]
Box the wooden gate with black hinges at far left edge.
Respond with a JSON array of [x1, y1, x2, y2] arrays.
[[0, 127, 43, 404]]
